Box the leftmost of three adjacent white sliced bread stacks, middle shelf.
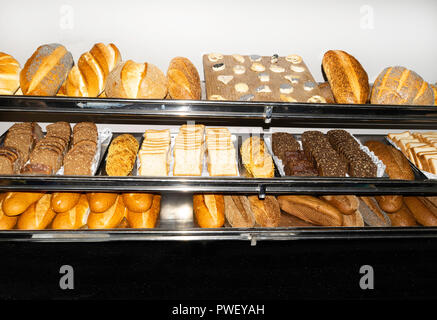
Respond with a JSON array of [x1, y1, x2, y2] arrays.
[[138, 129, 171, 176]]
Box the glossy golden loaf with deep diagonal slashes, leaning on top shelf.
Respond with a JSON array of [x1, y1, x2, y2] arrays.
[[63, 43, 121, 97]]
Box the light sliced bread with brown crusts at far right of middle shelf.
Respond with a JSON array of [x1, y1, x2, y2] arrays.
[[388, 131, 437, 174]]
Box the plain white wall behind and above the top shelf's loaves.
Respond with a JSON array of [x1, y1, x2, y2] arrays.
[[0, 0, 437, 83]]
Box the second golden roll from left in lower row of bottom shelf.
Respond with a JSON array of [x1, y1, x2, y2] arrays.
[[17, 193, 56, 230]]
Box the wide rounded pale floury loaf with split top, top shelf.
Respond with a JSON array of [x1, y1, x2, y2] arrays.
[[105, 60, 167, 99]]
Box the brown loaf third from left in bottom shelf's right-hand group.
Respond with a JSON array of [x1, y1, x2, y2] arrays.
[[248, 196, 281, 227]]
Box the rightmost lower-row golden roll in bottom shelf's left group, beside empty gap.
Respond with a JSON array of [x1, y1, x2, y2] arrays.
[[123, 195, 161, 228]]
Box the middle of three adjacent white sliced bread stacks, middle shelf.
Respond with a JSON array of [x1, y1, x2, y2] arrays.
[[173, 124, 205, 176]]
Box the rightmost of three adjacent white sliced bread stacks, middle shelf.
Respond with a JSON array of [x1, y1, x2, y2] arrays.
[[205, 128, 238, 177]]
